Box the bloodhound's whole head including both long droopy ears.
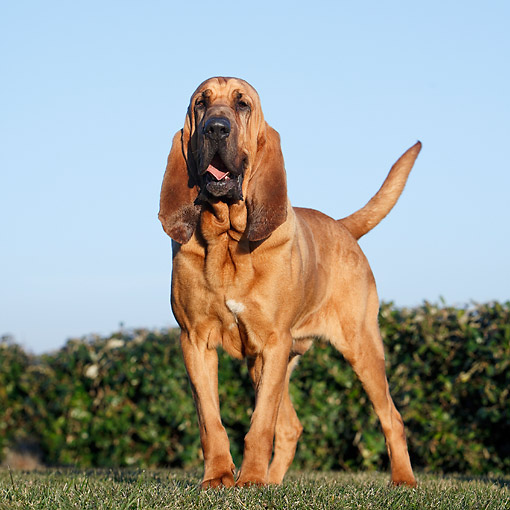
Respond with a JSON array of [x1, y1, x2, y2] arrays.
[[159, 77, 287, 244]]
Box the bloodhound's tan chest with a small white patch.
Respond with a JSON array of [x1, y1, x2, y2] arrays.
[[172, 234, 260, 357]]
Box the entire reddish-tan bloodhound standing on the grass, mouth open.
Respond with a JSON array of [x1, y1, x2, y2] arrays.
[[159, 77, 421, 488]]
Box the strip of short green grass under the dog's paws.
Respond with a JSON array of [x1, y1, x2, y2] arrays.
[[0, 469, 510, 510]]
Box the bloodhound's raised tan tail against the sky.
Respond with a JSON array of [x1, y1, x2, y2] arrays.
[[338, 142, 421, 239]]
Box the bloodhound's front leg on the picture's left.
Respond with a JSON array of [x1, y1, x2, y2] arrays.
[[181, 332, 235, 489]]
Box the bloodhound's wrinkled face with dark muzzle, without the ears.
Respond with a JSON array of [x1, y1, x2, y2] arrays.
[[188, 78, 263, 202]]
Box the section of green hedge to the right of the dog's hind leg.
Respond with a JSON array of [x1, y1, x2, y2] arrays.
[[381, 302, 510, 473]]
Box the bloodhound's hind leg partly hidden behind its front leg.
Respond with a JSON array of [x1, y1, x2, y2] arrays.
[[268, 355, 303, 484]]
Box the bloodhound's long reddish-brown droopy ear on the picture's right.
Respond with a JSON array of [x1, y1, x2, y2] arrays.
[[245, 123, 287, 241]]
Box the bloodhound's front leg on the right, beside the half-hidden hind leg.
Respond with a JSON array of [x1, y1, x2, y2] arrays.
[[236, 333, 292, 487]]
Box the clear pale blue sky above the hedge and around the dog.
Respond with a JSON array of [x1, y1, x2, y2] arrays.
[[0, 0, 510, 352]]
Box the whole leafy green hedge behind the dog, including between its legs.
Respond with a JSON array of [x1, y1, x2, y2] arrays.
[[0, 302, 510, 474]]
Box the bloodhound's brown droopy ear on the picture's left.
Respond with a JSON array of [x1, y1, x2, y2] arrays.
[[158, 127, 200, 244]]
